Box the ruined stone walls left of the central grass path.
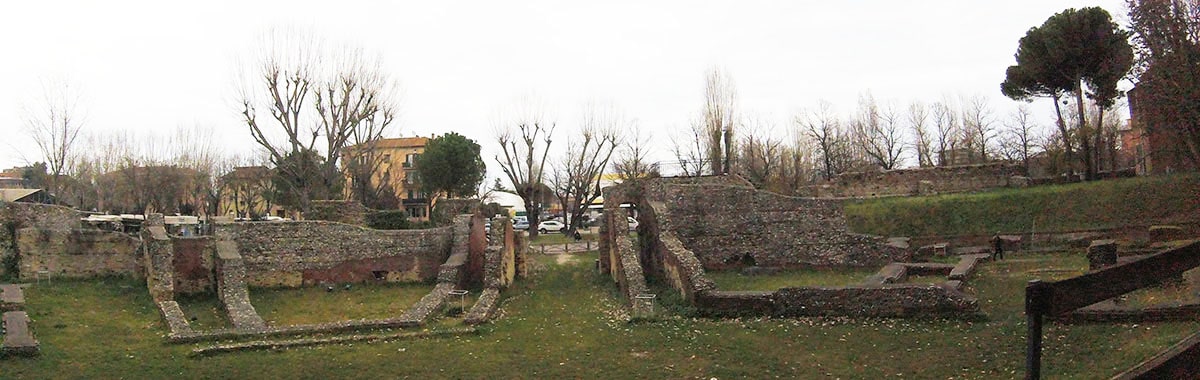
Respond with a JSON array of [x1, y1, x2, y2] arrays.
[[0, 200, 526, 351]]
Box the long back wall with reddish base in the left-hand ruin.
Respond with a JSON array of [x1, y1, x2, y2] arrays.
[[216, 222, 451, 286]]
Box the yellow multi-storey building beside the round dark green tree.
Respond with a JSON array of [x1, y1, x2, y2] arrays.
[[342, 137, 431, 221]]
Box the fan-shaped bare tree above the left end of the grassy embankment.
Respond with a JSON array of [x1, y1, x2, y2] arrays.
[[851, 94, 904, 170]]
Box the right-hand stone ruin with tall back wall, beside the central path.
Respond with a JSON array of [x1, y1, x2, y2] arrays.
[[600, 176, 979, 318]]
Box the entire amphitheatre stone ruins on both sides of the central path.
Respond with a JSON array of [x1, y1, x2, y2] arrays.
[[0, 165, 1200, 378]]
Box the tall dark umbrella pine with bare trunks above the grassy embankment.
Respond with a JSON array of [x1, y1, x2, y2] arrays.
[[1001, 7, 1133, 179]]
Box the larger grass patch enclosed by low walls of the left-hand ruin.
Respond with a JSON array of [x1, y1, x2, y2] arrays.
[[250, 284, 436, 326]]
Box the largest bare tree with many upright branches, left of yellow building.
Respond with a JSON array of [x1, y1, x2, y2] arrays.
[[241, 34, 397, 211]]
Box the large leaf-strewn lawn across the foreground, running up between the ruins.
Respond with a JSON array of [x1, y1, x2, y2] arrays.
[[0, 250, 1200, 379]]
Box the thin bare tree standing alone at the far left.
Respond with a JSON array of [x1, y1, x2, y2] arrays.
[[24, 83, 83, 201]]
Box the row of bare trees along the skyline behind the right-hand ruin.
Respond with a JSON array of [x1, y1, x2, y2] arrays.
[[672, 71, 1124, 193]]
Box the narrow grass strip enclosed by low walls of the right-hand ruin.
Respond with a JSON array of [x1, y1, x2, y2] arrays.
[[706, 269, 878, 290]]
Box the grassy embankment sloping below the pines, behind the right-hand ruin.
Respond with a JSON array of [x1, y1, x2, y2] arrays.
[[846, 174, 1200, 236]]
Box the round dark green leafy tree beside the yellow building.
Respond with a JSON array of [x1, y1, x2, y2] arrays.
[[416, 132, 487, 198]]
